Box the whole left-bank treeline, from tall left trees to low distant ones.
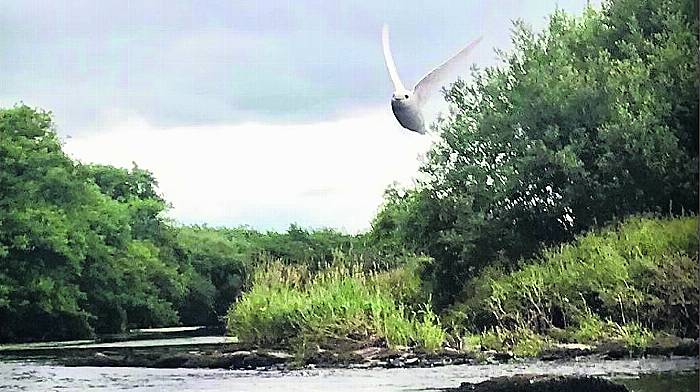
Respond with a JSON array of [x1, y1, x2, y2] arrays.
[[0, 106, 371, 340]]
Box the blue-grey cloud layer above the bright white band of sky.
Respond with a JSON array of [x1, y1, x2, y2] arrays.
[[0, 0, 600, 134]]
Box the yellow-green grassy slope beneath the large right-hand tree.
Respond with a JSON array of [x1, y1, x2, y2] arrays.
[[448, 217, 700, 347]]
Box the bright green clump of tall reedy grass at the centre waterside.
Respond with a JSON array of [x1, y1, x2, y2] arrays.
[[228, 254, 445, 351]]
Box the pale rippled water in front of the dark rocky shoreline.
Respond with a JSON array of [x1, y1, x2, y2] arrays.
[[0, 358, 698, 392]]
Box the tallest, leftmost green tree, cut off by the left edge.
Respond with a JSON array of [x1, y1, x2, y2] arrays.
[[0, 106, 101, 338]]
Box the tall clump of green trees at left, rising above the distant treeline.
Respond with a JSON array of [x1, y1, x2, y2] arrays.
[[0, 106, 186, 340]]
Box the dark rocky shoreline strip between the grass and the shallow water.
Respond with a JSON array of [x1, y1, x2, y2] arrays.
[[0, 336, 698, 370]]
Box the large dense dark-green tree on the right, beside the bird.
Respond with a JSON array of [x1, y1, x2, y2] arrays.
[[373, 0, 699, 306]]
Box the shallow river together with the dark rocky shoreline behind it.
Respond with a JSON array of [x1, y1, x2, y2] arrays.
[[0, 335, 698, 392]]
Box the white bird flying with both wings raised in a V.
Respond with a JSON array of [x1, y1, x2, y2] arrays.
[[382, 25, 481, 134]]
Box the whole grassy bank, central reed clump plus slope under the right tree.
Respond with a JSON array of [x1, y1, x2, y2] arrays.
[[228, 217, 700, 356]]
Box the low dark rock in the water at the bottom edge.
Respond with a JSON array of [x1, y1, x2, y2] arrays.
[[448, 376, 629, 392]]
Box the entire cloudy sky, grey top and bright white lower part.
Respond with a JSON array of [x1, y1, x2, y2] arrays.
[[0, 0, 595, 232]]
